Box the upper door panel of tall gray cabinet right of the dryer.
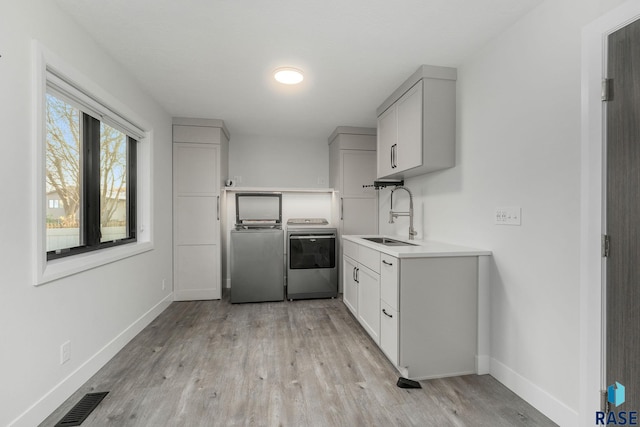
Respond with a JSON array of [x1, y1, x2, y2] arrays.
[[340, 150, 377, 198]]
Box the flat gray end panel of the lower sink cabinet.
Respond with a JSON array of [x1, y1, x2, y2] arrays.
[[400, 257, 478, 378]]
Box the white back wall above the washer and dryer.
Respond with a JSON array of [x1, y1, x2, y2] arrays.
[[229, 134, 331, 188]]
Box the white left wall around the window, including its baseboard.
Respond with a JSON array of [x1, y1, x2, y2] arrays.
[[0, 0, 172, 426]]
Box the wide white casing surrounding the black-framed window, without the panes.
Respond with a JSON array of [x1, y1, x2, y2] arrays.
[[32, 41, 153, 286]]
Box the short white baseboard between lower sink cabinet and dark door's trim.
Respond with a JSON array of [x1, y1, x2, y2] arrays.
[[489, 359, 578, 427]]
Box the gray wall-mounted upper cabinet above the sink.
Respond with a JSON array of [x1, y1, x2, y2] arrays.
[[377, 65, 457, 178]]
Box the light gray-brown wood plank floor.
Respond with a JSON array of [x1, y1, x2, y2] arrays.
[[41, 299, 555, 427]]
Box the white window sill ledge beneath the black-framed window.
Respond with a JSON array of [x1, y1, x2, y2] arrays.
[[35, 241, 153, 286]]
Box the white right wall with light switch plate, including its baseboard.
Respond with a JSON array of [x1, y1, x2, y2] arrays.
[[380, 0, 622, 426]]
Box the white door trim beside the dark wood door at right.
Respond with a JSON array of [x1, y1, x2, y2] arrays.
[[579, 0, 640, 425]]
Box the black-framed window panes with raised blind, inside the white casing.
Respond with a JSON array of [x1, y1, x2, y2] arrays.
[[44, 70, 139, 260]]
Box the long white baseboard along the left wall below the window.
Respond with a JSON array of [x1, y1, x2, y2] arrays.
[[9, 294, 173, 427]]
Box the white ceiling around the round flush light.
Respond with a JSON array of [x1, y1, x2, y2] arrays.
[[57, 0, 542, 139]]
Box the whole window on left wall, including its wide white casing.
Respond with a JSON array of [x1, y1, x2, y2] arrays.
[[32, 41, 152, 286]]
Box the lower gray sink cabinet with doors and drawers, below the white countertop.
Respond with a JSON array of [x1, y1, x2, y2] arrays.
[[343, 239, 479, 379]]
